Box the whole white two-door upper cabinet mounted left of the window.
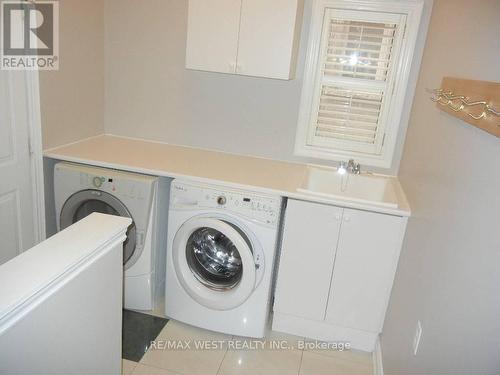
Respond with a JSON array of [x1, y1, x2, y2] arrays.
[[186, 0, 304, 80]]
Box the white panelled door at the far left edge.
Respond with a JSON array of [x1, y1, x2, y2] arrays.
[[0, 71, 37, 264]]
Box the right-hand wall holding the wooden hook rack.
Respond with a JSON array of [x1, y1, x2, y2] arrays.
[[382, 0, 500, 375]]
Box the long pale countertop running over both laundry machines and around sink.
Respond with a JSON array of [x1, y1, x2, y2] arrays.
[[44, 135, 410, 216]]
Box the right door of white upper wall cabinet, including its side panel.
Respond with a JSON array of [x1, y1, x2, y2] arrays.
[[237, 0, 304, 79]]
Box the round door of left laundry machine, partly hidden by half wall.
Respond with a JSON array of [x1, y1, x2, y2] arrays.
[[60, 190, 136, 264]]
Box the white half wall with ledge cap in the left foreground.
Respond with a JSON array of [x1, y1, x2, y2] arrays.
[[0, 214, 130, 375]]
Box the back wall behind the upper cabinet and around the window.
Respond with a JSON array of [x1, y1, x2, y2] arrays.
[[105, 0, 432, 174]]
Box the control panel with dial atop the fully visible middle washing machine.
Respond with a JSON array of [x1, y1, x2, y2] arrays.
[[171, 181, 282, 225]]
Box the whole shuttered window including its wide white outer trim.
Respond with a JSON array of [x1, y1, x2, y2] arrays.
[[296, 0, 421, 167]]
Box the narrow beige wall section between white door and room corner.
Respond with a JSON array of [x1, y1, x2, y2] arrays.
[[40, 0, 104, 149]]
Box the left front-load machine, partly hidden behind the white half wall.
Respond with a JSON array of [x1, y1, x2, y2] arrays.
[[54, 162, 171, 311]]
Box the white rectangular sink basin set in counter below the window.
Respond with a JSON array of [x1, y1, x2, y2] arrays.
[[297, 166, 398, 208]]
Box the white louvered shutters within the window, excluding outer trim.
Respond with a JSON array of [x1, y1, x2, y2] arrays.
[[307, 9, 406, 155]]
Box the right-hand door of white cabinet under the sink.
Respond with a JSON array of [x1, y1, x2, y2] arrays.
[[326, 209, 405, 332]]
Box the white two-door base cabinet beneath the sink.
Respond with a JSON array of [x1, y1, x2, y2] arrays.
[[273, 199, 407, 351]]
